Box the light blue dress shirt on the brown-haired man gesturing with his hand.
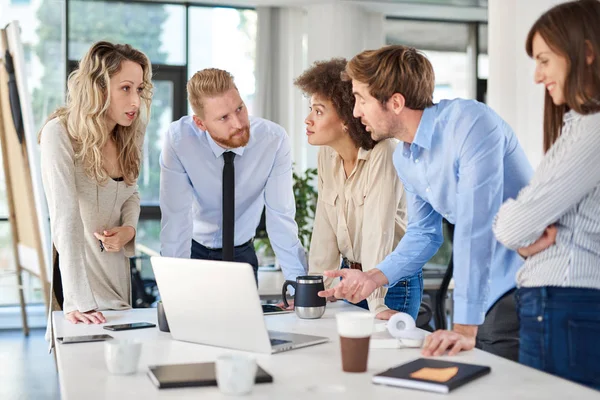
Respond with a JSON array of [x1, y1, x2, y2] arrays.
[[377, 99, 533, 325]]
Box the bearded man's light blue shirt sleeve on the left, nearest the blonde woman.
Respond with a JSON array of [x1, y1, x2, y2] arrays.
[[160, 129, 193, 258]]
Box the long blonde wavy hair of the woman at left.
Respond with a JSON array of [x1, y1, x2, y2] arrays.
[[41, 42, 152, 185]]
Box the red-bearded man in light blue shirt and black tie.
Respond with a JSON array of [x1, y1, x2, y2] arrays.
[[160, 69, 306, 280]]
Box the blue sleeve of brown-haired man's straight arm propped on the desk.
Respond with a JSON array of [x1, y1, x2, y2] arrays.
[[453, 113, 505, 325]]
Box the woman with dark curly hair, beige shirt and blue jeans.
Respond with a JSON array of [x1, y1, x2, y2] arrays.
[[294, 58, 423, 319]]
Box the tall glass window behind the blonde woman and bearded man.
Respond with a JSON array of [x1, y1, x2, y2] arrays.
[[0, 0, 257, 305]]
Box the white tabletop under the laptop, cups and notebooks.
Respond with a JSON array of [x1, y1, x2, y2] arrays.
[[53, 302, 600, 400]]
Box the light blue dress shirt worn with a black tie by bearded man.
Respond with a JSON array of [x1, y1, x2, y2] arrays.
[[160, 116, 306, 280]]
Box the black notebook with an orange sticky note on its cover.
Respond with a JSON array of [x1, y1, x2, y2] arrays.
[[373, 358, 491, 393]]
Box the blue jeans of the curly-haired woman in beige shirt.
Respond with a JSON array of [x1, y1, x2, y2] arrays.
[[342, 267, 423, 320]]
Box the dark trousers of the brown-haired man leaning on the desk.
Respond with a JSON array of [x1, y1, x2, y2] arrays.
[[475, 289, 519, 361]]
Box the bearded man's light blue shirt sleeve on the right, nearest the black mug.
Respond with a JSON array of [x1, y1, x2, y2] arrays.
[[265, 132, 306, 280]]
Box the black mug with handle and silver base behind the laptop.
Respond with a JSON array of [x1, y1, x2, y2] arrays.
[[281, 275, 327, 319]]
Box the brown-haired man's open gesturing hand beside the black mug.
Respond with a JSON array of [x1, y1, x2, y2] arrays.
[[318, 268, 387, 303]]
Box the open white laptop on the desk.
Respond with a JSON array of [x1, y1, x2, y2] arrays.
[[151, 257, 329, 353]]
